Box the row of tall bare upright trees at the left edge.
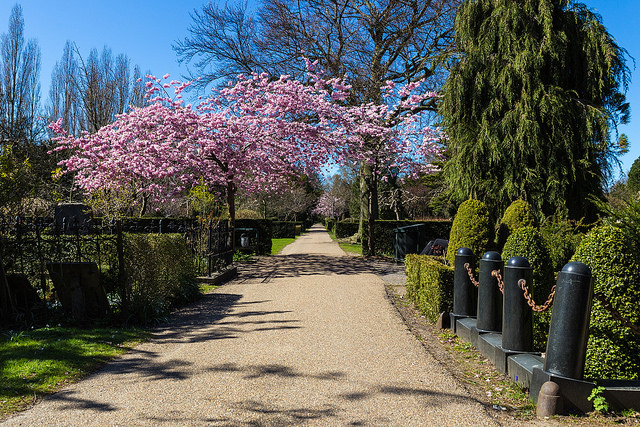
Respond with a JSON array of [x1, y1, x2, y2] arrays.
[[0, 5, 145, 213]]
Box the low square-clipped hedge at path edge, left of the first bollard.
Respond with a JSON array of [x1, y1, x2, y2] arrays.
[[405, 254, 453, 323]]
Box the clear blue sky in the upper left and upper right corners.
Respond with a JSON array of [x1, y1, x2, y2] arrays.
[[0, 0, 640, 178]]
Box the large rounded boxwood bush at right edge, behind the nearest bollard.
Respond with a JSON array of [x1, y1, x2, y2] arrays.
[[572, 225, 640, 380]]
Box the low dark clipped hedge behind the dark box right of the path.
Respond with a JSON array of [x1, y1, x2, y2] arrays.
[[362, 220, 451, 256]]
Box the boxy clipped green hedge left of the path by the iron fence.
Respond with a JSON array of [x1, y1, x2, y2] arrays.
[[124, 234, 200, 323]]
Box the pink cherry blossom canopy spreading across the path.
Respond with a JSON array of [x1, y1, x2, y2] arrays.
[[50, 63, 440, 247]]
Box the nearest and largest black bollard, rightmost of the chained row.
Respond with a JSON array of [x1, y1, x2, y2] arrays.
[[544, 262, 593, 380]]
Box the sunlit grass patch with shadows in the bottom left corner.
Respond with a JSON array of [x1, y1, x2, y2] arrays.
[[0, 326, 148, 418]]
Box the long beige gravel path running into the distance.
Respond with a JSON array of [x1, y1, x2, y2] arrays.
[[6, 225, 497, 426]]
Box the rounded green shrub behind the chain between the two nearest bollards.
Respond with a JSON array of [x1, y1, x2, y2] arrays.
[[502, 227, 554, 351]]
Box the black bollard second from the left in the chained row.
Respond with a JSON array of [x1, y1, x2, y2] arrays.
[[476, 252, 502, 332]]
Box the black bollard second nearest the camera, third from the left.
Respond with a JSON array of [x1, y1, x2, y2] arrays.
[[502, 256, 533, 352]]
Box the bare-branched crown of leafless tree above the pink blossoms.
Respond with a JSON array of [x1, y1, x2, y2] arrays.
[[174, 0, 460, 97]]
